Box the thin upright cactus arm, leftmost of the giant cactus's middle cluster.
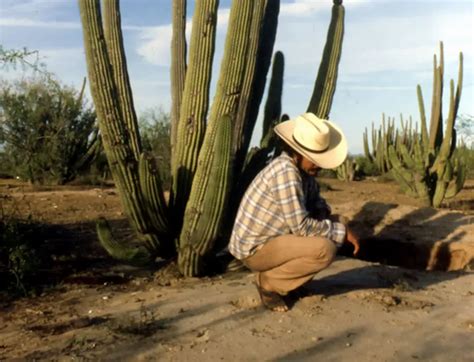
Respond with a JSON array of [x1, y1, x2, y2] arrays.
[[170, 0, 186, 163]]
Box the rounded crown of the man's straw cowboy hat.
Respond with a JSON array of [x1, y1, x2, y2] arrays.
[[293, 113, 331, 152]]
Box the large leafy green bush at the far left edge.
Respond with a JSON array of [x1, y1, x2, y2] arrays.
[[0, 75, 98, 184]]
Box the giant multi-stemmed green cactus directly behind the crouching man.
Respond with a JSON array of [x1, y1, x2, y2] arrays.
[[78, 0, 343, 275]]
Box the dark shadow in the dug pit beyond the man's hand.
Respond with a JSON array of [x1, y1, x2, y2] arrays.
[[340, 202, 473, 271]]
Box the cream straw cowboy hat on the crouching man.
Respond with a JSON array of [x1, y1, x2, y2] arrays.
[[275, 113, 347, 168]]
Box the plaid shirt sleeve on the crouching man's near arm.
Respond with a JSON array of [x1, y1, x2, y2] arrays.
[[272, 167, 346, 245]]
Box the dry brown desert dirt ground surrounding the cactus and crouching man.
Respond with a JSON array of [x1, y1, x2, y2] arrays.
[[0, 180, 474, 361]]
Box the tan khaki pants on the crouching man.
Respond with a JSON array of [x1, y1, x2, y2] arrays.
[[242, 235, 337, 295]]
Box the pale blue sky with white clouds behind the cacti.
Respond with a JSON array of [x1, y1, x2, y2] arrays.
[[0, 0, 474, 153]]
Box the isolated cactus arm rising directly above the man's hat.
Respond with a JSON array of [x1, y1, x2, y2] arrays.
[[308, 0, 344, 119]]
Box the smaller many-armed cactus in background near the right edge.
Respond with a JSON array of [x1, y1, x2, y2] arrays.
[[389, 43, 466, 207]]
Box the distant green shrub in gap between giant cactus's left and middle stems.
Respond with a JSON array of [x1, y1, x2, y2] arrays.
[[139, 108, 171, 189]]
